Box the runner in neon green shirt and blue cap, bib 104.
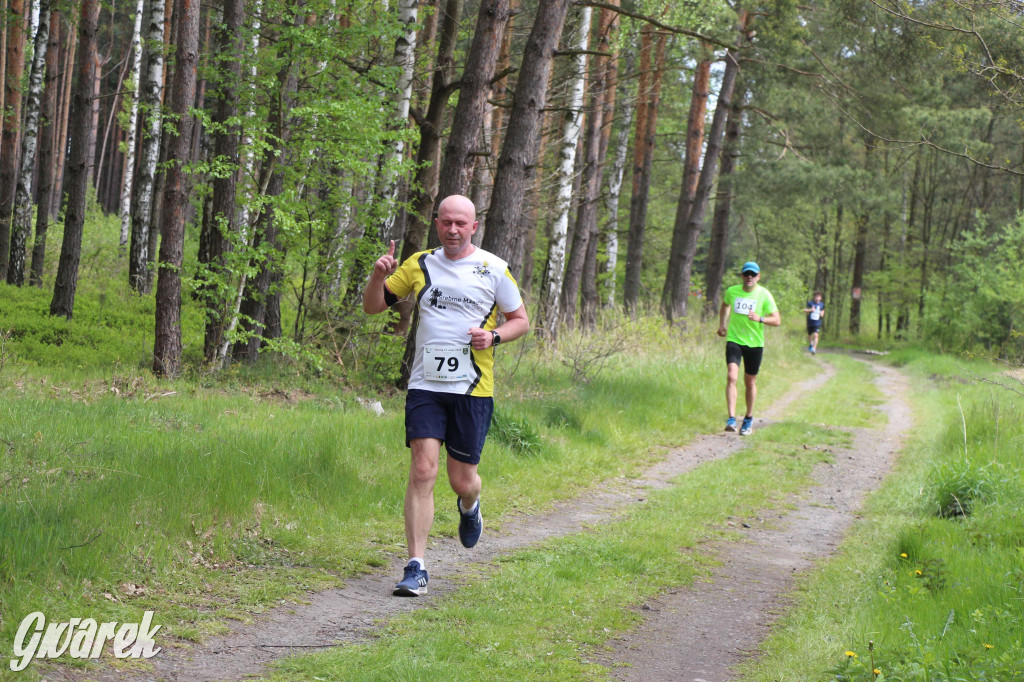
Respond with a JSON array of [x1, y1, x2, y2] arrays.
[[718, 260, 782, 435]]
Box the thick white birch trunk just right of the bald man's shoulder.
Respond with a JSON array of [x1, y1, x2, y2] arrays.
[[538, 6, 594, 339]]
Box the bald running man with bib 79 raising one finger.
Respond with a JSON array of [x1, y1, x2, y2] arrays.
[[362, 195, 529, 597]]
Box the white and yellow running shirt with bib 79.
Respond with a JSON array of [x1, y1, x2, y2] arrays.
[[384, 248, 522, 397]]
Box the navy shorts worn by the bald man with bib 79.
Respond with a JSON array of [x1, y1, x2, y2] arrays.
[[406, 388, 495, 464]]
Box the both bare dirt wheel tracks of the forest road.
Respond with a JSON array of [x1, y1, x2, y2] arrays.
[[54, 356, 910, 682]]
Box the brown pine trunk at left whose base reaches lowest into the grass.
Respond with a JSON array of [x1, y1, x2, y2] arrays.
[[153, 0, 200, 377]]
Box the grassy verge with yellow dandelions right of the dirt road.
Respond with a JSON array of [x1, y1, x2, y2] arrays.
[[744, 353, 1024, 680]]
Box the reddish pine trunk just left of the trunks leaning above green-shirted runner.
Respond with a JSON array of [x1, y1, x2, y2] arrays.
[[623, 25, 668, 316]]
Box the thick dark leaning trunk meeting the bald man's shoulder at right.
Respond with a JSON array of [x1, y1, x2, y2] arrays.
[[482, 0, 568, 273]]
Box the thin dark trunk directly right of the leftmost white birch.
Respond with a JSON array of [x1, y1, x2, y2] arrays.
[[29, 10, 60, 287]]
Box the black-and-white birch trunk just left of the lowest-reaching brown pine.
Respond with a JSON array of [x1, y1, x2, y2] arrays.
[[128, 0, 166, 294]]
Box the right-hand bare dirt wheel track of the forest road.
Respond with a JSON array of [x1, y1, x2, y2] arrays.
[[603, 358, 911, 682]]
